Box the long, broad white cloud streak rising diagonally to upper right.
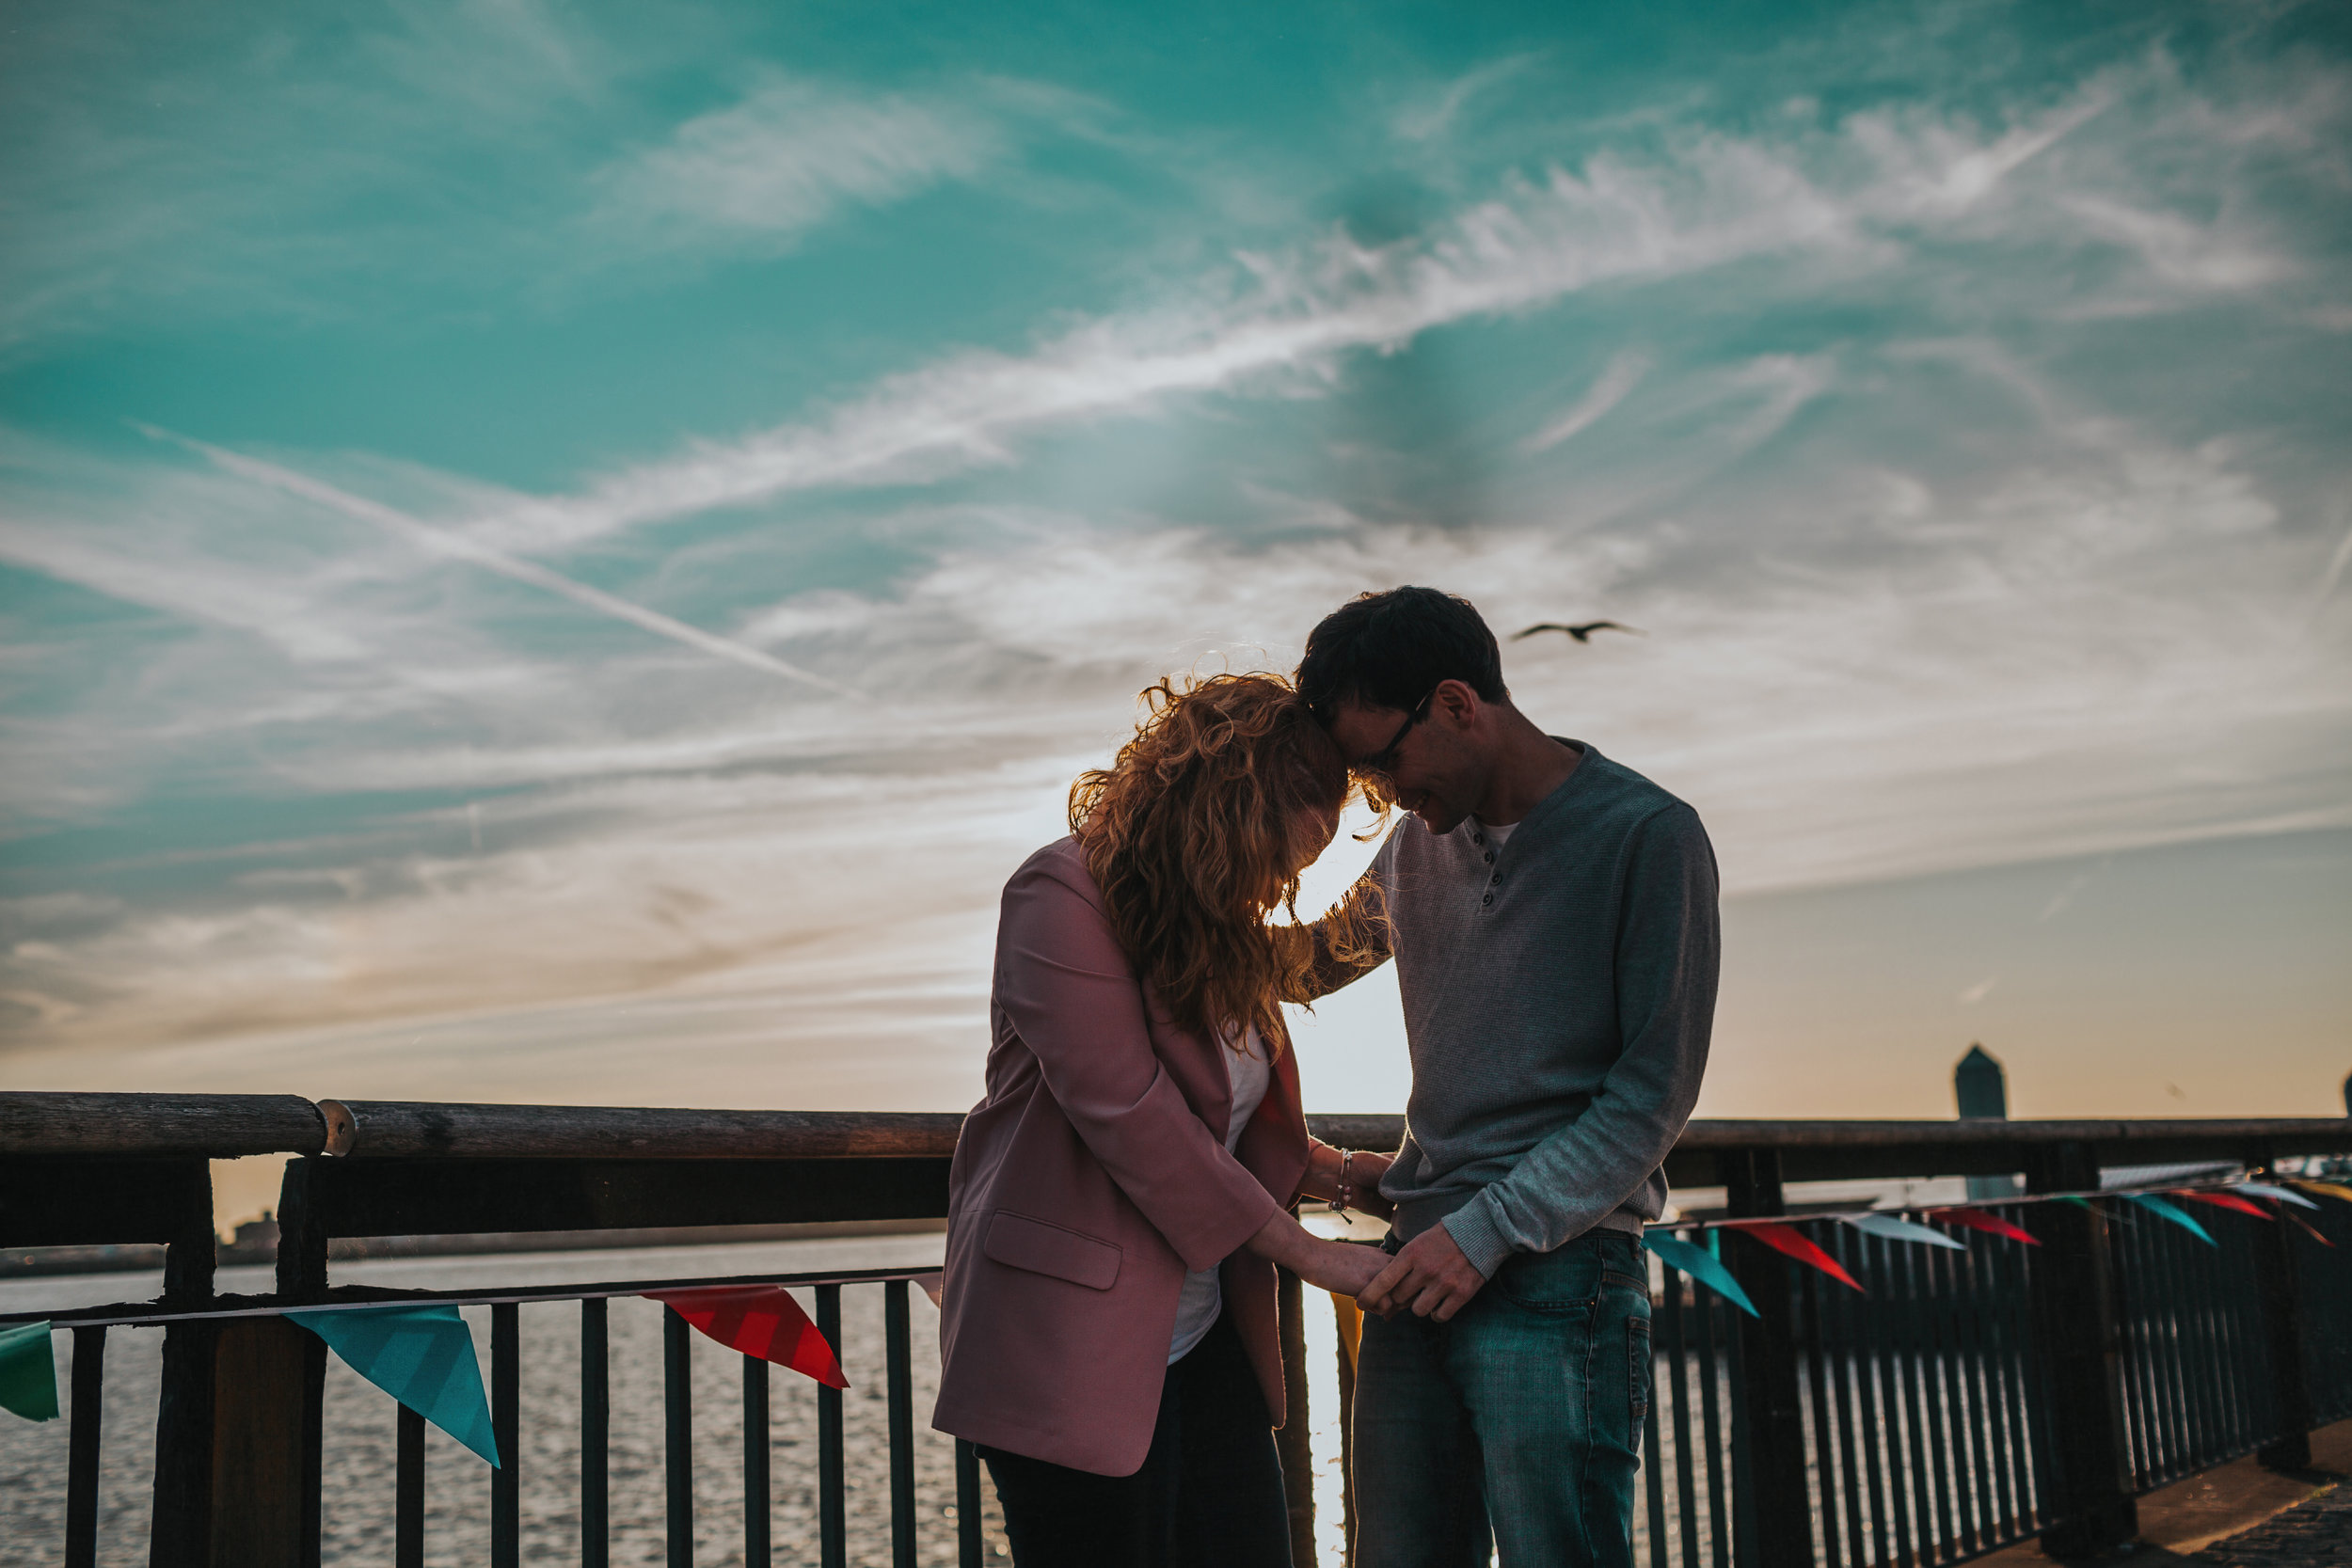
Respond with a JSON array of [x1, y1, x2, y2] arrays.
[[458, 55, 2291, 550]]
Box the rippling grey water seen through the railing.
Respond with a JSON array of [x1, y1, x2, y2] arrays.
[[0, 1234, 1341, 1568]]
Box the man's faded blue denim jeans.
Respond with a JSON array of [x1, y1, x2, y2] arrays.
[[1355, 1229, 1649, 1568]]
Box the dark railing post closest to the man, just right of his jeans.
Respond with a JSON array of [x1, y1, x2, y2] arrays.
[[1722, 1149, 1814, 1568]]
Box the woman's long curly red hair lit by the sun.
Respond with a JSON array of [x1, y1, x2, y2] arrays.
[[1071, 674, 1350, 1055]]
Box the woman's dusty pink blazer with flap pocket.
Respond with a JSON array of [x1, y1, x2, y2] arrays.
[[931, 837, 1308, 1477]]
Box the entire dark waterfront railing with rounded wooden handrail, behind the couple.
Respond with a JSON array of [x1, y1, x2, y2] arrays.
[[0, 1096, 2352, 1568]]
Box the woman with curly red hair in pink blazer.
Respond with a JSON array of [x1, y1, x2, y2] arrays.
[[931, 674, 1386, 1568]]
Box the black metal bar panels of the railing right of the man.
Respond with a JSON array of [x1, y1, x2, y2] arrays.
[[1637, 1204, 2352, 1568]]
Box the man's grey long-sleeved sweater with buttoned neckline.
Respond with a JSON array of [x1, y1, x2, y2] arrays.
[[1372, 740, 1720, 1276]]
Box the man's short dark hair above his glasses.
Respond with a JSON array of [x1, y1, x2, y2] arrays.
[[1298, 588, 1510, 726]]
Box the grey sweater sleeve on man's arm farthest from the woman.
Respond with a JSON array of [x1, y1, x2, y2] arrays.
[[1444, 801, 1722, 1276]]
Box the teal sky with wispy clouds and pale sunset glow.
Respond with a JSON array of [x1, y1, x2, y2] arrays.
[[0, 0, 2352, 1117]]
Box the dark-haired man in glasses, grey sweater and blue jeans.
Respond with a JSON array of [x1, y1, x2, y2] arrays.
[[1298, 588, 1717, 1568]]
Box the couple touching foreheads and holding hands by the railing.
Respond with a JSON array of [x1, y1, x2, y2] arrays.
[[934, 588, 1717, 1568]]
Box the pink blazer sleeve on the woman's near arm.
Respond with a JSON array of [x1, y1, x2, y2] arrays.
[[997, 863, 1279, 1270]]
